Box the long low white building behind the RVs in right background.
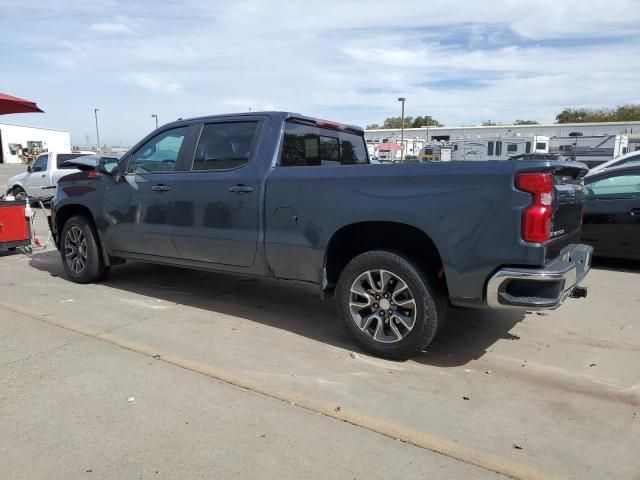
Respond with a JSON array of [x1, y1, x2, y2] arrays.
[[365, 121, 640, 155]]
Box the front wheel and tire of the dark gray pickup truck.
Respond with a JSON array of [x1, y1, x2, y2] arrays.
[[60, 215, 110, 283]]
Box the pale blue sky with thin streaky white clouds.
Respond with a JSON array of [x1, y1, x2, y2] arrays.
[[0, 0, 640, 146]]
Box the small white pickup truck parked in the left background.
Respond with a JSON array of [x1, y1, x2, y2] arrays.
[[7, 151, 94, 200]]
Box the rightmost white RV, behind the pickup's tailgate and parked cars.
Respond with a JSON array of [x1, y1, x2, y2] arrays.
[[549, 135, 629, 167]]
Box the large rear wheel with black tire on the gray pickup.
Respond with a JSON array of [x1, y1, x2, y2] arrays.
[[336, 250, 447, 360]]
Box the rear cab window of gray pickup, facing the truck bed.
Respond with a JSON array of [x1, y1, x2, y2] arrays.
[[280, 122, 369, 167]]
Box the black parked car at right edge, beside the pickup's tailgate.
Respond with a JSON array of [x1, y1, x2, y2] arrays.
[[582, 163, 640, 260]]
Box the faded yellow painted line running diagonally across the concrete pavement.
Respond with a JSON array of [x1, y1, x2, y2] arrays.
[[0, 302, 556, 480]]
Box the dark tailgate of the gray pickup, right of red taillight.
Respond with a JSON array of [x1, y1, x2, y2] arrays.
[[546, 164, 587, 260]]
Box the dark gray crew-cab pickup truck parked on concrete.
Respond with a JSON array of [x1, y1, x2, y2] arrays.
[[52, 112, 592, 358]]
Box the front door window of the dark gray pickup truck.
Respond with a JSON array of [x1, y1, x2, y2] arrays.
[[127, 127, 187, 174]]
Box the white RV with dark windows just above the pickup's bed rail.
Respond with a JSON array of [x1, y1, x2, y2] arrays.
[[451, 135, 549, 160]]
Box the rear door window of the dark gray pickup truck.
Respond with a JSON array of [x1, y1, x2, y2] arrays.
[[192, 122, 258, 170]]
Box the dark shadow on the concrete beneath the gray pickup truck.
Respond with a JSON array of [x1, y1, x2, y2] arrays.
[[30, 251, 524, 367]]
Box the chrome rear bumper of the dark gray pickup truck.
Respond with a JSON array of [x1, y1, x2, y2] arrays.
[[486, 244, 593, 310]]
